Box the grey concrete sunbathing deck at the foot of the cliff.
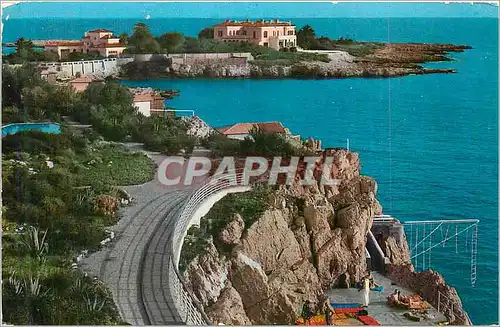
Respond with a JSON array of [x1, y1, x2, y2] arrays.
[[328, 272, 446, 326]]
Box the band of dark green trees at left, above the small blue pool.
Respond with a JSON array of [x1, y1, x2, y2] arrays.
[[2, 64, 194, 154]]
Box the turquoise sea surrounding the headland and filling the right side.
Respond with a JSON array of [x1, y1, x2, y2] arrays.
[[3, 17, 498, 324]]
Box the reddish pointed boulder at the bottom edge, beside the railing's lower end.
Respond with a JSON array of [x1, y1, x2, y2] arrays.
[[206, 284, 251, 325]]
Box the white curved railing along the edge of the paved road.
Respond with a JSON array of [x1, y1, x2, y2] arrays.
[[168, 171, 249, 325]]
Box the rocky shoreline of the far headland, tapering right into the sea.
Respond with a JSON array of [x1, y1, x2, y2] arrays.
[[122, 42, 471, 79]]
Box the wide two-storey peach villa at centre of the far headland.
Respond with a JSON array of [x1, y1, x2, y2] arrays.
[[214, 19, 297, 50]]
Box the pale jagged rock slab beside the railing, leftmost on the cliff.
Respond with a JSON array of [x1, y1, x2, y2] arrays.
[[184, 241, 229, 306]]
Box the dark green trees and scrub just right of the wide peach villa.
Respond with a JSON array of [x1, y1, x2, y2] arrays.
[[297, 25, 384, 57]]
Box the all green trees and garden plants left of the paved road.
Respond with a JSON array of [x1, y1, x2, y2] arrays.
[[2, 64, 175, 325]]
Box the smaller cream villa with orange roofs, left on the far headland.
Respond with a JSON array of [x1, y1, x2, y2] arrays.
[[44, 28, 126, 58]]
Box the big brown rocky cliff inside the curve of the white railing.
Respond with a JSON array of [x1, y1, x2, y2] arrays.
[[184, 150, 381, 325]]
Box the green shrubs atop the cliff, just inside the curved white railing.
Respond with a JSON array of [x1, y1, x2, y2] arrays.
[[179, 185, 270, 272]]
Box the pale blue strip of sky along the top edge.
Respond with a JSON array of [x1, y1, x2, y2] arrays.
[[3, 2, 498, 19]]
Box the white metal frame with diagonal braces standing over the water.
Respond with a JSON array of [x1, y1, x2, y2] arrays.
[[402, 219, 479, 286]]
